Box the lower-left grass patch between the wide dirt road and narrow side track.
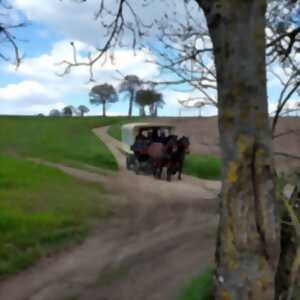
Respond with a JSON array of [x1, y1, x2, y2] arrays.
[[0, 154, 110, 278]]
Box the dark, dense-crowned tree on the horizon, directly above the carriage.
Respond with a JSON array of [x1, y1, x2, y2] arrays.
[[136, 89, 163, 115]]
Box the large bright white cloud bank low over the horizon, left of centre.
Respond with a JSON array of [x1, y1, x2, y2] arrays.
[[0, 40, 158, 114]]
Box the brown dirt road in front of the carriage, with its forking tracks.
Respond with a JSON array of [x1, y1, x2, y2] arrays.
[[0, 128, 220, 300]]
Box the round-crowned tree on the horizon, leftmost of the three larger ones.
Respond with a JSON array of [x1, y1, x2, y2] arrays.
[[89, 83, 118, 117]]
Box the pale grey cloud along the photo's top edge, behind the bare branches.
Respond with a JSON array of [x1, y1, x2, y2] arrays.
[[13, 0, 203, 47]]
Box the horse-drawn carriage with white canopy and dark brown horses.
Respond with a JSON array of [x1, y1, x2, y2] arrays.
[[122, 123, 189, 180]]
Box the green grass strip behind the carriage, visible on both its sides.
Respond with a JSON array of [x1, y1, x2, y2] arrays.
[[108, 124, 221, 180]]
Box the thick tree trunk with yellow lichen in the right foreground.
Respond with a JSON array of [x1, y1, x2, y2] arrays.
[[197, 0, 280, 300]]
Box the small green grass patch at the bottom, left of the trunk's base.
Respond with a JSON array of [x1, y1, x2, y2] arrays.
[[176, 268, 214, 300]]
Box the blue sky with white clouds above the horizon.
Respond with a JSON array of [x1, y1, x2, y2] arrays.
[[0, 0, 298, 116]]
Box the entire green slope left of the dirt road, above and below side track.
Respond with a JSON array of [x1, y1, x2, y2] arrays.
[[0, 117, 131, 278]]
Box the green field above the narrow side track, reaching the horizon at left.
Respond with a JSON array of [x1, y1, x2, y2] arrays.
[[0, 117, 140, 170]]
